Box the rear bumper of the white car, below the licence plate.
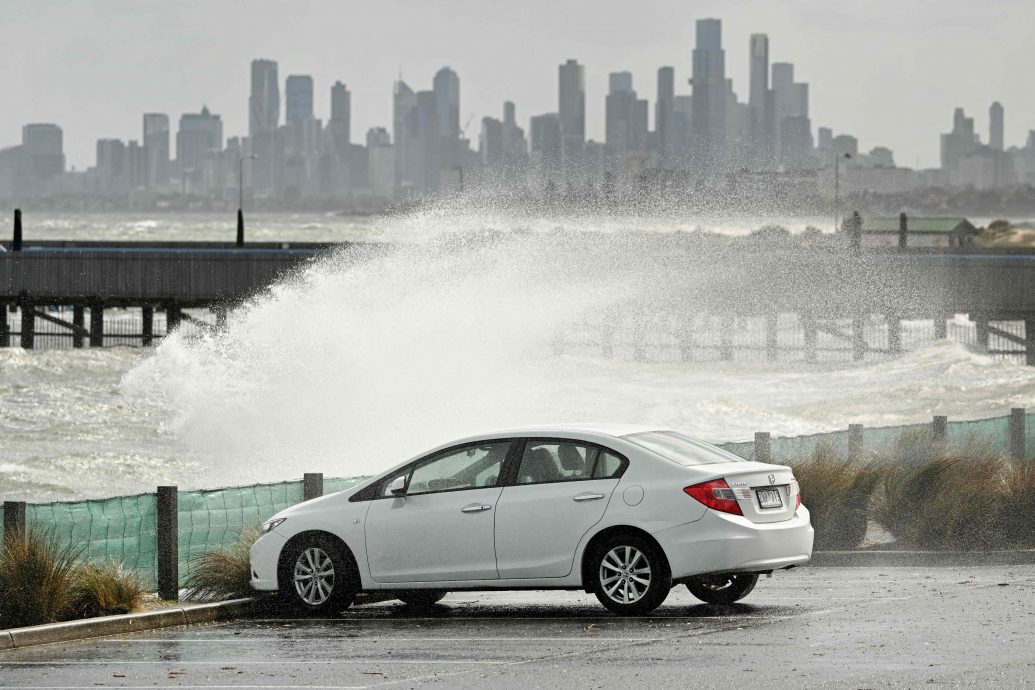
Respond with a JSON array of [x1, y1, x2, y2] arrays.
[[653, 506, 814, 580]]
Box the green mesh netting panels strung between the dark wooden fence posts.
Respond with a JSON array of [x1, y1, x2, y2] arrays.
[[4, 414, 1035, 588]]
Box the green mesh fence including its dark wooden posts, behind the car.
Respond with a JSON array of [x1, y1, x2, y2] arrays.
[[3, 408, 1035, 599]]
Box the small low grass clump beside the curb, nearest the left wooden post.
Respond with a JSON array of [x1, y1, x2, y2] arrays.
[[64, 561, 144, 619]]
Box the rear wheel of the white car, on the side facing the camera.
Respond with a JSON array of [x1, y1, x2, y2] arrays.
[[587, 534, 672, 616]]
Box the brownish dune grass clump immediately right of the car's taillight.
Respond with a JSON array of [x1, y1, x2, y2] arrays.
[[791, 444, 884, 550]]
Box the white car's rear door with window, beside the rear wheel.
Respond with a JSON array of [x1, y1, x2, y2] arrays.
[[496, 439, 628, 579]]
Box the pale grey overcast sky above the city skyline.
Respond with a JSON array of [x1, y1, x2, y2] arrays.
[[0, 0, 1035, 169]]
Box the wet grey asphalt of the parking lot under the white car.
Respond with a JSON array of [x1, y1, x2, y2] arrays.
[[0, 566, 1035, 688]]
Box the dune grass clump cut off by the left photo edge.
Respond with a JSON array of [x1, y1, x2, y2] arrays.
[[0, 529, 82, 628]]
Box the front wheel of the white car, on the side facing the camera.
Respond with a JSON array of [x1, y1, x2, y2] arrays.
[[278, 535, 359, 616]]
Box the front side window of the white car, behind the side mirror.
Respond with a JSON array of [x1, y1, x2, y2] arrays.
[[395, 441, 510, 496]]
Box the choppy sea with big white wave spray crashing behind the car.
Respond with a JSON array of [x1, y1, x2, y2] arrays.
[[0, 210, 1035, 501]]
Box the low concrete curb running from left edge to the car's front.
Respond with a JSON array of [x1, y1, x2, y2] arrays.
[[0, 598, 256, 651]]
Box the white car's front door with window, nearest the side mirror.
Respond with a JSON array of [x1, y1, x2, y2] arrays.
[[365, 440, 512, 582]]
